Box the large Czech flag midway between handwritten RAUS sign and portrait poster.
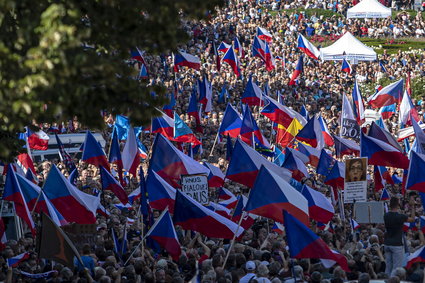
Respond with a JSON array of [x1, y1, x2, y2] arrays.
[[245, 166, 309, 225]]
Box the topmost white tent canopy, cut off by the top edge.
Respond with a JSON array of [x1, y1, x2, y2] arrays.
[[347, 0, 391, 19]]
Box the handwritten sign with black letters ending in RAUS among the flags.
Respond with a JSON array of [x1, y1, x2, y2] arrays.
[[181, 174, 209, 205]]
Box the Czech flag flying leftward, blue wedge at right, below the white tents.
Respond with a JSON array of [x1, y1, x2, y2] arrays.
[[367, 79, 404, 108]]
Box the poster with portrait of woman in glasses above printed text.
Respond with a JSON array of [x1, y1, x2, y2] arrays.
[[344, 158, 367, 203]]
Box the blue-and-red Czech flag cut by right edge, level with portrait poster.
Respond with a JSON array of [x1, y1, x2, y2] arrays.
[[406, 151, 425, 193]]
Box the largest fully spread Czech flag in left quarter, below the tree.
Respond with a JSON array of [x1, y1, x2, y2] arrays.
[[43, 165, 100, 224]]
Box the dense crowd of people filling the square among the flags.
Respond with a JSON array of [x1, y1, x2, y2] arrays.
[[0, 0, 425, 283]]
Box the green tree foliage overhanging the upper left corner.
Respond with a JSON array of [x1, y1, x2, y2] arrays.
[[0, 0, 222, 160]]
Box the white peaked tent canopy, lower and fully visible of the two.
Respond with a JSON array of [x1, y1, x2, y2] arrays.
[[320, 32, 376, 63]]
